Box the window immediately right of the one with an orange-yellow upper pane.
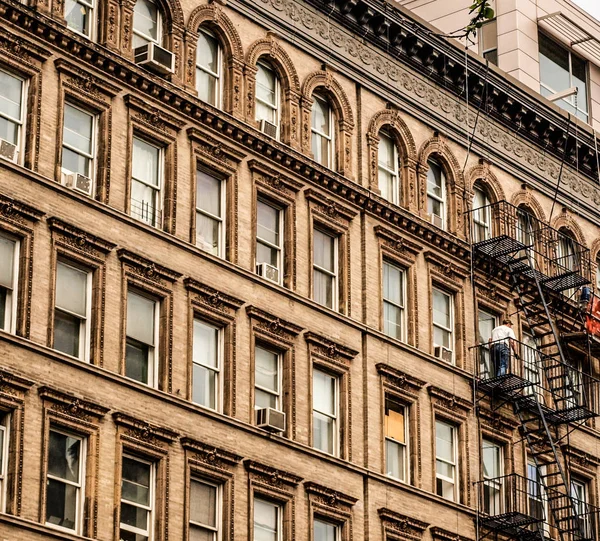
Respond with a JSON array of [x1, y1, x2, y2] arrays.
[[435, 420, 458, 501]]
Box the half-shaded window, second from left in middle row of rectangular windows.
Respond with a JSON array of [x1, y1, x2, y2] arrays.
[[54, 261, 92, 361]]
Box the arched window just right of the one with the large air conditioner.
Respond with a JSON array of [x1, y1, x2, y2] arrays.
[[196, 28, 223, 107]]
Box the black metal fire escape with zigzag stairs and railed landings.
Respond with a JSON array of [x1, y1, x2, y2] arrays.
[[470, 201, 600, 541]]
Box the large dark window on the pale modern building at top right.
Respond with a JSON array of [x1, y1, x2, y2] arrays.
[[538, 33, 588, 122]]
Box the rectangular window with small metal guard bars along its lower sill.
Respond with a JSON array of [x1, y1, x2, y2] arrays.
[[131, 137, 163, 227]]
